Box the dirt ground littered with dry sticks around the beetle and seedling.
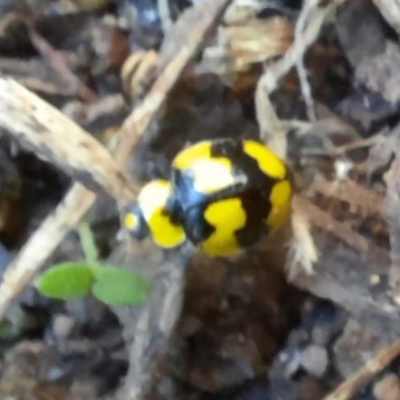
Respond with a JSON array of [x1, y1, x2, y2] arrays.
[[0, 0, 400, 400]]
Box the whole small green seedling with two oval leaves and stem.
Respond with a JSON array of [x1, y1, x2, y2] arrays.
[[35, 223, 150, 306]]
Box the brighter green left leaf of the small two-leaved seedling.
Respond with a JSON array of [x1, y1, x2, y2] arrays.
[[35, 262, 94, 300]]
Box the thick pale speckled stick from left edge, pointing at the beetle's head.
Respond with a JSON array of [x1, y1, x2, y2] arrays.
[[0, 78, 137, 201]]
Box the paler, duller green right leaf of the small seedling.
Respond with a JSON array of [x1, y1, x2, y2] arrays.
[[92, 266, 150, 306]]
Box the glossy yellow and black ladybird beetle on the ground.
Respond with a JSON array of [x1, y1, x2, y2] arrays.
[[125, 139, 292, 256]]
